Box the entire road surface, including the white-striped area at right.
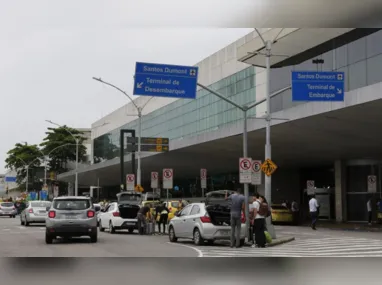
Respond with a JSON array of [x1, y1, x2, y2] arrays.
[[0, 217, 382, 257]]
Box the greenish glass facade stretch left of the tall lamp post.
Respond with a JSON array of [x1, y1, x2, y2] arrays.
[[94, 67, 256, 163]]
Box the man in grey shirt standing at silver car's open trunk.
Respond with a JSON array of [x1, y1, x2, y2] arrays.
[[225, 189, 245, 248]]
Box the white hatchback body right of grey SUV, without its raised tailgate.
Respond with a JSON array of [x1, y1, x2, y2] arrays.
[[98, 202, 140, 234]]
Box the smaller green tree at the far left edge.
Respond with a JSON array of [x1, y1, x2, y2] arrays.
[[5, 143, 43, 184]]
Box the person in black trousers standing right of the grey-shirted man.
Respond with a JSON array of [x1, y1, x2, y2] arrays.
[[252, 194, 269, 248]]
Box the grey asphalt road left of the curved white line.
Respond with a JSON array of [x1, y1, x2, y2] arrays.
[[0, 217, 198, 257]]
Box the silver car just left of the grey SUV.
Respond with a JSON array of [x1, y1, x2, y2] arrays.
[[20, 201, 52, 224]]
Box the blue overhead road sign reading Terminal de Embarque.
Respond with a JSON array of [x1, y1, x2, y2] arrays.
[[292, 71, 345, 101]]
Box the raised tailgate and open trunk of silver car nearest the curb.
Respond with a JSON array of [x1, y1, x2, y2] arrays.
[[205, 190, 233, 226]]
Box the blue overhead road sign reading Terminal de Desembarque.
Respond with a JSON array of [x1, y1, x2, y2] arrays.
[[134, 62, 198, 99]]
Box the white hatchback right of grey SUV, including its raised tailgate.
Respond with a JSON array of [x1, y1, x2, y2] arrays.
[[98, 191, 141, 234]]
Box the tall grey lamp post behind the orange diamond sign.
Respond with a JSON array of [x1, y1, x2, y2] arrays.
[[264, 41, 276, 239]]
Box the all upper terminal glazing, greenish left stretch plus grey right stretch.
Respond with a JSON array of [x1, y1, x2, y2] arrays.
[[94, 31, 382, 162]]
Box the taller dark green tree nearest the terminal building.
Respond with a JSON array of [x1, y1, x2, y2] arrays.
[[40, 126, 86, 173]]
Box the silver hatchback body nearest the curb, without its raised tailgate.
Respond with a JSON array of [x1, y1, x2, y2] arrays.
[[169, 203, 246, 245]]
